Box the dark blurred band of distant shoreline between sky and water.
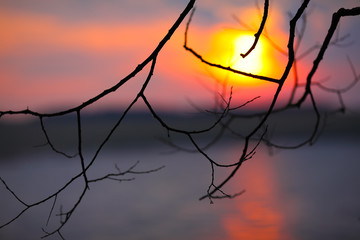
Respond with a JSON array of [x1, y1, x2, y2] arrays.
[[0, 111, 360, 158]]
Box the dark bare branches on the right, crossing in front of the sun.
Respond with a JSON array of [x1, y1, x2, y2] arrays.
[[184, 0, 360, 202]]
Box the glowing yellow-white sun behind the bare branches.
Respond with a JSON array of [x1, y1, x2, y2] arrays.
[[205, 29, 272, 85]]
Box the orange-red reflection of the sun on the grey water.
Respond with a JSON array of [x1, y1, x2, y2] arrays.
[[222, 153, 292, 240]]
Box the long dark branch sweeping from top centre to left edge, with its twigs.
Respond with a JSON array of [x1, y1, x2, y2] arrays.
[[0, 0, 195, 239]]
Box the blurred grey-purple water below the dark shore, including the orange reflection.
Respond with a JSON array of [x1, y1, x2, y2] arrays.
[[0, 138, 360, 240]]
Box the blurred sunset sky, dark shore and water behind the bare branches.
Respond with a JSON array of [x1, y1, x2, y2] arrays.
[[0, 0, 360, 239]]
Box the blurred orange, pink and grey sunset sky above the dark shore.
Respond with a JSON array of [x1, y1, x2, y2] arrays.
[[0, 0, 360, 111]]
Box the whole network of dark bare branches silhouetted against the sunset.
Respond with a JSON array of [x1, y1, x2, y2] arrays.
[[0, 0, 360, 239]]
